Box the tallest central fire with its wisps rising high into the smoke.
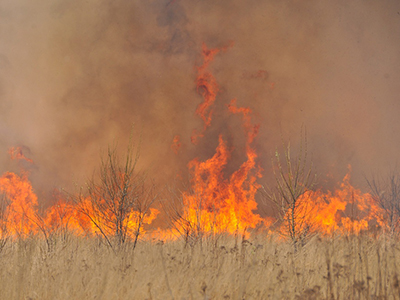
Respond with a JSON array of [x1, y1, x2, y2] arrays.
[[175, 45, 262, 239]]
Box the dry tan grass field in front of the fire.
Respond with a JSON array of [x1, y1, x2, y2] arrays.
[[0, 236, 400, 300]]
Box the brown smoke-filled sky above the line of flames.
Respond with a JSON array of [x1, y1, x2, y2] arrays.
[[0, 0, 400, 202]]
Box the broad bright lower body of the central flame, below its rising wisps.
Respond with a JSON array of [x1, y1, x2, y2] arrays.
[[182, 136, 262, 234]]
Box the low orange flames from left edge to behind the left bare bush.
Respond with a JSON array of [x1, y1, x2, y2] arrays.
[[0, 172, 159, 238]]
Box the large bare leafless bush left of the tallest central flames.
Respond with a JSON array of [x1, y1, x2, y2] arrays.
[[75, 138, 157, 250]]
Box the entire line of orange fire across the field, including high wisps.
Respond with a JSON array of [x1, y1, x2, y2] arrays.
[[0, 44, 394, 239]]
